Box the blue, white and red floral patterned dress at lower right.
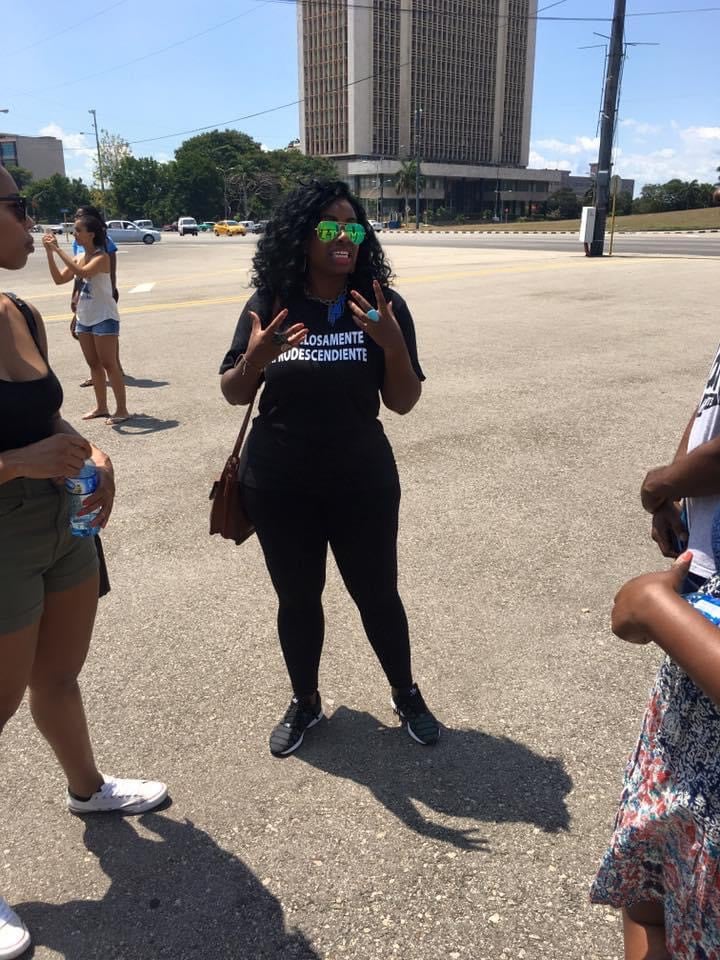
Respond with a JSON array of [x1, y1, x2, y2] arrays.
[[590, 575, 720, 960]]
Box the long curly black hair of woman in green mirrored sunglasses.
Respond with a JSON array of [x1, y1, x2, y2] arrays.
[[251, 180, 393, 300]]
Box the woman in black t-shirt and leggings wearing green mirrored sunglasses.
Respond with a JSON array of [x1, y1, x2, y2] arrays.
[[220, 180, 440, 756]]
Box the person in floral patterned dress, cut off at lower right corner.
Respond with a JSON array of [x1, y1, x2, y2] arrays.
[[591, 544, 720, 960]]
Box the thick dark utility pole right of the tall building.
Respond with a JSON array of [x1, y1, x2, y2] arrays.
[[588, 0, 626, 257]]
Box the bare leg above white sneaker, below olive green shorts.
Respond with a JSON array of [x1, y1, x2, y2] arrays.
[[29, 574, 103, 797]]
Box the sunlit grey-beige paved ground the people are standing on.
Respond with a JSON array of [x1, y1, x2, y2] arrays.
[[5, 237, 720, 960]]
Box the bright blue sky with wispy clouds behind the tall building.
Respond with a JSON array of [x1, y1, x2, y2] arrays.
[[0, 0, 720, 186]]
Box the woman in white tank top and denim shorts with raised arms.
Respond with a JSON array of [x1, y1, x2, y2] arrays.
[[43, 215, 130, 425]]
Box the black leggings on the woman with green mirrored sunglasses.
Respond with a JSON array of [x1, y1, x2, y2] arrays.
[[243, 486, 412, 697]]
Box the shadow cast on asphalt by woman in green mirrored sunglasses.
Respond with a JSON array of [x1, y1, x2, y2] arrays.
[[297, 707, 572, 850]]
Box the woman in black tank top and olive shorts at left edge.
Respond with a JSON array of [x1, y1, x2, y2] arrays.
[[0, 166, 167, 957]]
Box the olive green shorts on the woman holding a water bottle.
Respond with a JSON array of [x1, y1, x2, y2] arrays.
[[0, 478, 98, 634]]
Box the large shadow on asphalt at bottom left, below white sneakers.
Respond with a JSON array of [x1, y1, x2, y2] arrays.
[[17, 813, 319, 960]]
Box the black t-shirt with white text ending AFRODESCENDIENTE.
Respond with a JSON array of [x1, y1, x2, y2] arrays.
[[220, 290, 425, 491]]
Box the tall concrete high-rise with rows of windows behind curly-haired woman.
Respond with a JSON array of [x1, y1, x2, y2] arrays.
[[298, 0, 560, 219]]
